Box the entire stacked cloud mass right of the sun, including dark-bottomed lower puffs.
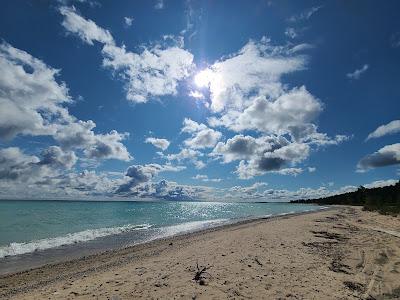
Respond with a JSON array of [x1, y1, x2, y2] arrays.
[[195, 38, 349, 179]]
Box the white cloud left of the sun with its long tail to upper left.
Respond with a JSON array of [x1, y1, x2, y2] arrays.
[[60, 7, 194, 103]]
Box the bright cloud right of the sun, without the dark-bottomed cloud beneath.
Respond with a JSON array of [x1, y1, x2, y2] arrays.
[[202, 38, 346, 140]]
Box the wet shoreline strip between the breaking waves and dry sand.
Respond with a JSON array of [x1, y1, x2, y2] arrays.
[[0, 206, 324, 278]]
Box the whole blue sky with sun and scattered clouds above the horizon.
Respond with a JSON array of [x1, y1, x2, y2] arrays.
[[0, 0, 400, 201]]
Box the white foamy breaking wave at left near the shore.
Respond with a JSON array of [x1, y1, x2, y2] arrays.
[[0, 224, 151, 258]]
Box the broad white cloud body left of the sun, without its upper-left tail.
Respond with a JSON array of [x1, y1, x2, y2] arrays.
[[102, 44, 193, 103]]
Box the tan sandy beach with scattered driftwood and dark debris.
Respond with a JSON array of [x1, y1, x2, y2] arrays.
[[0, 207, 400, 300]]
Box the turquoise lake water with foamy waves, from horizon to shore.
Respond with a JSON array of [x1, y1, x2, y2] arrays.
[[0, 201, 320, 258]]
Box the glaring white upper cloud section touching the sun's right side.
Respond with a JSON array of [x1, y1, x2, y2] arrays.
[[195, 38, 306, 112]]
